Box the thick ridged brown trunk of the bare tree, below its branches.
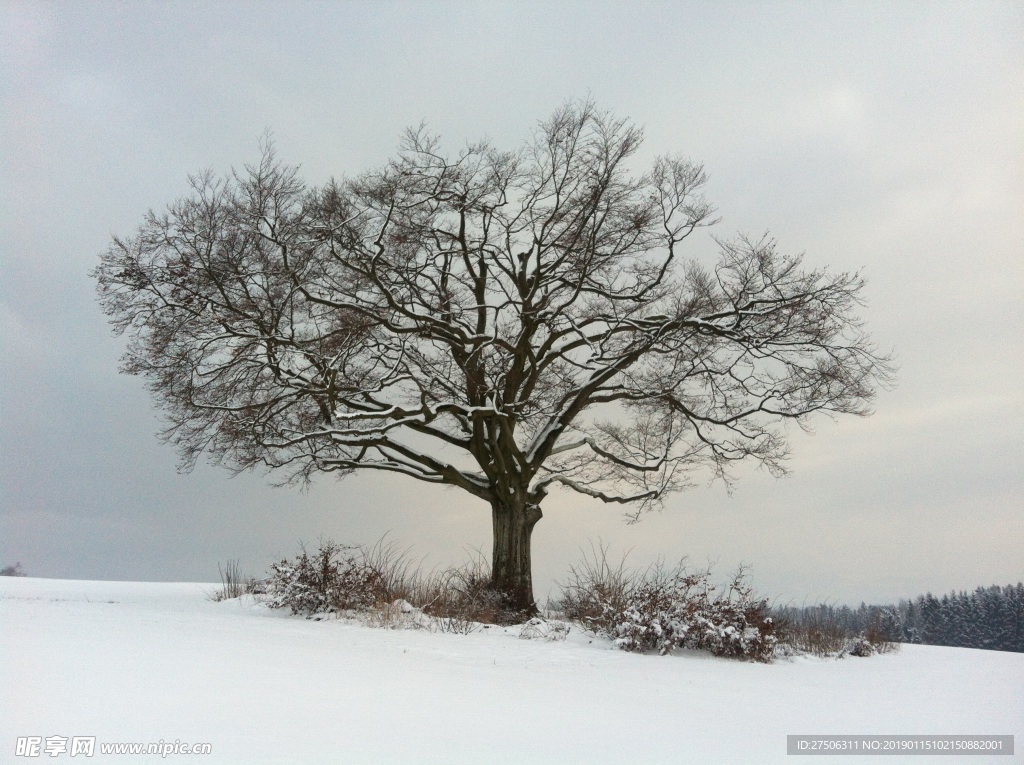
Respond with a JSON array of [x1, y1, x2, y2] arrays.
[[490, 498, 542, 617]]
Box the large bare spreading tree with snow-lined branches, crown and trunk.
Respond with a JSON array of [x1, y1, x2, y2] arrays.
[[94, 102, 891, 611]]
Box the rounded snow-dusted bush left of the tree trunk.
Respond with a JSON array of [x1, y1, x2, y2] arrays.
[[263, 540, 387, 615]]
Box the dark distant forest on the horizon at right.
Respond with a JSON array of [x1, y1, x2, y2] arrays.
[[773, 582, 1024, 653]]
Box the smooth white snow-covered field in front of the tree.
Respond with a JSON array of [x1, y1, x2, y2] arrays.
[[0, 578, 1024, 765]]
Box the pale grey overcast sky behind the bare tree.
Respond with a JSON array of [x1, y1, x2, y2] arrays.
[[0, 0, 1024, 604]]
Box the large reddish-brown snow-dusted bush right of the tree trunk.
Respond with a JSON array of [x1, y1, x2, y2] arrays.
[[561, 547, 778, 662]]
